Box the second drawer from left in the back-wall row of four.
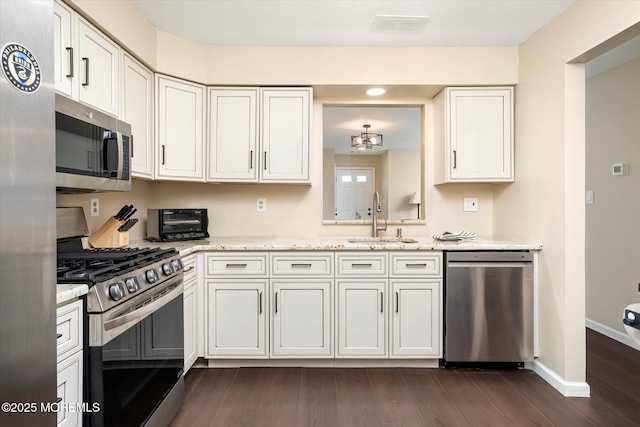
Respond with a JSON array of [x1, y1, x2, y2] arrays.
[[271, 253, 333, 277]]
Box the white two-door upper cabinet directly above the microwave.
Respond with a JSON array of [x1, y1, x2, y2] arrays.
[[54, 2, 120, 116]]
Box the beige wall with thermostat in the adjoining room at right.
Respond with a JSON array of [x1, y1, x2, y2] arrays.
[[586, 58, 640, 333]]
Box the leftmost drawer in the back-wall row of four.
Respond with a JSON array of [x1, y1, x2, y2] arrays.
[[205, 252, 268, 277]]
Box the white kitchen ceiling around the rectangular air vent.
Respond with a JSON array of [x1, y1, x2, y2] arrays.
[[133, 0, 573, 46]]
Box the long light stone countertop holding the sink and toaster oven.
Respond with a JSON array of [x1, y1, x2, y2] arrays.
[[130, 236, 542, 256]]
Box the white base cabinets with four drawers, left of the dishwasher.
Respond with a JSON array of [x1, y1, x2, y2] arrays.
[[204, 251, 442, 363]]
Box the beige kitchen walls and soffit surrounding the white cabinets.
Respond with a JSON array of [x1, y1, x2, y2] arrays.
[[59, 0, 640, 388]]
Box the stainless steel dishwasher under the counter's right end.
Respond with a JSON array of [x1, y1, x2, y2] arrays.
[[444, 251, 533, 365]]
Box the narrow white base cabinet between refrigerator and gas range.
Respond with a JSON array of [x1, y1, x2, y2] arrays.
[[56, 300, 84, 427]]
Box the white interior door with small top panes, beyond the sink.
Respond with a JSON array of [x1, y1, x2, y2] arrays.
[[335, 167, 375, 220]]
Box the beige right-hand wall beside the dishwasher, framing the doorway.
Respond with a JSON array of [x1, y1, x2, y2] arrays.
[[494, 1, 640, 382]]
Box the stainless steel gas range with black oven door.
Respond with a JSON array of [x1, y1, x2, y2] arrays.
[[57, 210, 184, 426]]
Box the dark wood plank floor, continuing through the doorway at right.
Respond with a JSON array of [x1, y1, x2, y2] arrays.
[[172, 329, 640, 427]]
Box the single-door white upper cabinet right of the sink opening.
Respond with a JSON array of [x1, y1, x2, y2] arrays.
[[434, 87, 514, 184]]
